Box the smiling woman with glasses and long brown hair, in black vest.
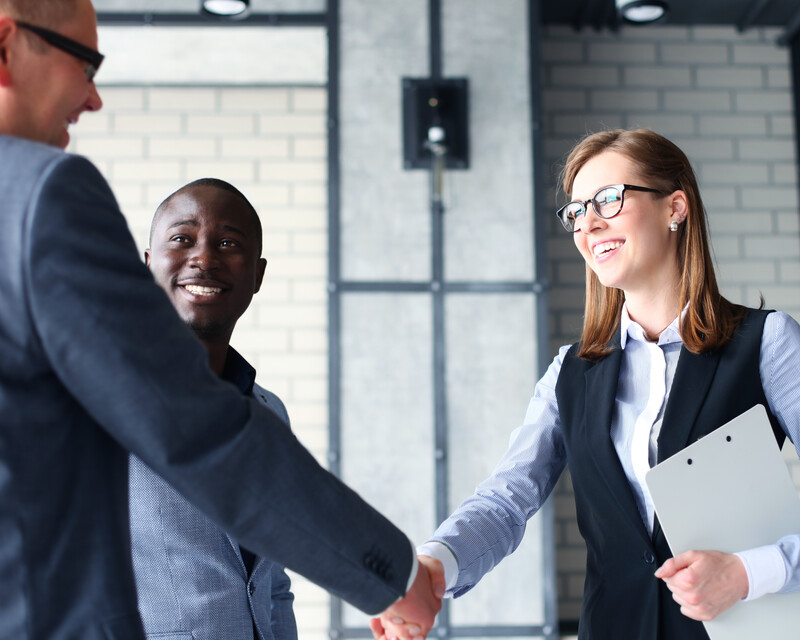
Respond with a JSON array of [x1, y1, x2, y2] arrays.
[[373, 129, 800, 640]]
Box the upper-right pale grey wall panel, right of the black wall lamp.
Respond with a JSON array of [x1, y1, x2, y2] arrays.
[[442, 0, 536, 281]]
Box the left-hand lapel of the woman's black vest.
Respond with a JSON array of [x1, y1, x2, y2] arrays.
[[585, 334, 650, 540]]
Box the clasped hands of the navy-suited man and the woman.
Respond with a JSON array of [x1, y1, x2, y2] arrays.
[[369, 556, 445, 640]]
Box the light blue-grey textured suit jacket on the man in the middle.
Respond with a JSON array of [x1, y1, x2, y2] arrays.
[[129, 348, 297, 640]]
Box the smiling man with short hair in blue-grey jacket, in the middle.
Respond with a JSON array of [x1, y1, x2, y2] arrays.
[[130, 178, 297, 640]]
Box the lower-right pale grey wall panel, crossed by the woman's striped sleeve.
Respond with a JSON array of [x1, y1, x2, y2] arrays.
[[446, 294, 545, 625]]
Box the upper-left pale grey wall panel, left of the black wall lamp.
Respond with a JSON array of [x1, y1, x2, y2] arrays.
[[339, 0, 431, 281]]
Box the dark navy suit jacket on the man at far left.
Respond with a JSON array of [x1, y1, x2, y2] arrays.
[[0, 136, 414, 640]]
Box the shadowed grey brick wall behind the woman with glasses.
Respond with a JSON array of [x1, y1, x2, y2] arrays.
[[542, 27, 800, 620]]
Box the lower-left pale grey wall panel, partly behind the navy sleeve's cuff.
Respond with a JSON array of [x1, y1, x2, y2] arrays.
[[341, 293, 435, 627]]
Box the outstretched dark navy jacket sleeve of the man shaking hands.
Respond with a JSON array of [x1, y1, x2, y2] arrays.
[[22, 154, 413, 613]]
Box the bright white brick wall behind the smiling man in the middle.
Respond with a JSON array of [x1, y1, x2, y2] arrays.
[[71, 86, 329, 640]]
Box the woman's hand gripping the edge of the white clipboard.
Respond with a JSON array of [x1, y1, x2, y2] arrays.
[[656, 551, 750, 621]]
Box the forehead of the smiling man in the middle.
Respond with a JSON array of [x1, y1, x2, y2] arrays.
[[156, 186, 257, 236]]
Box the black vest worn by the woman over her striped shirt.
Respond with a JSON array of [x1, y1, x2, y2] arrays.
[[556, 310, 784, 640]]
